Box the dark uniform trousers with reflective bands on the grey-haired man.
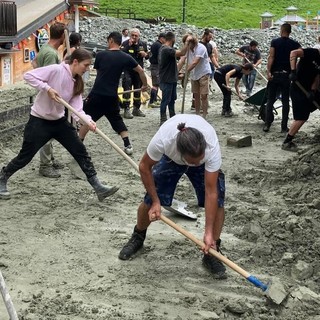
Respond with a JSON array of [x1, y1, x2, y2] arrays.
[[122, 70, 142, 108]]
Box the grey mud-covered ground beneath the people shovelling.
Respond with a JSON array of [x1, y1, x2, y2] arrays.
[[0, 78, 320, 320]]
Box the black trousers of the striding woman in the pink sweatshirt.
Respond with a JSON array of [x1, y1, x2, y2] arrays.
[[4, 115, 97, 179]]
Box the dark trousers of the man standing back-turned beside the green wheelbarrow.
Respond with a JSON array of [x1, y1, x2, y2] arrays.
[[265, 73, 290, 128]]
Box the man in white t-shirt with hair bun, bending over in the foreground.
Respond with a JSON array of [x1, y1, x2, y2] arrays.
[[119, 114, 226, 279]]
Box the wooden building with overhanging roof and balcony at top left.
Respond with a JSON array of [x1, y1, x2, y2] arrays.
[[0, 0, 96, 87]]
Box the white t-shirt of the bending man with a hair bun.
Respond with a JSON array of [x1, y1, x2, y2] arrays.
[[147, 114, 221, 172]]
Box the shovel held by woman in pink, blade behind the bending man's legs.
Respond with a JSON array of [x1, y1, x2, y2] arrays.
[[58, 98, 197, 220]]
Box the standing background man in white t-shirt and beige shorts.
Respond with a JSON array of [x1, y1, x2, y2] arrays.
[[187, 38, 211, 118]]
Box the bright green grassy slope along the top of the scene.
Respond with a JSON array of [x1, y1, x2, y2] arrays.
[[99, 0, 320, 29]]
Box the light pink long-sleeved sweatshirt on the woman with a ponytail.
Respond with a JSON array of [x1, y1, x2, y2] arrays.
[[24, 62, 91, 121]]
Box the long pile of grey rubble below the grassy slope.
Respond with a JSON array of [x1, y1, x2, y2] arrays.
[[80, 16, 318, 57]]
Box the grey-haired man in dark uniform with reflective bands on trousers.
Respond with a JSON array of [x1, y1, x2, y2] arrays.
[[121, 28, 149, 119]]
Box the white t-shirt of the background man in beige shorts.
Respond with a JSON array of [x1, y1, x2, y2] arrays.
[[188, 43, 211, 80]]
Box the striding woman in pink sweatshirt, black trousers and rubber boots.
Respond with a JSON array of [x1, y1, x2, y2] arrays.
[[0, 49, 118, 201]]
